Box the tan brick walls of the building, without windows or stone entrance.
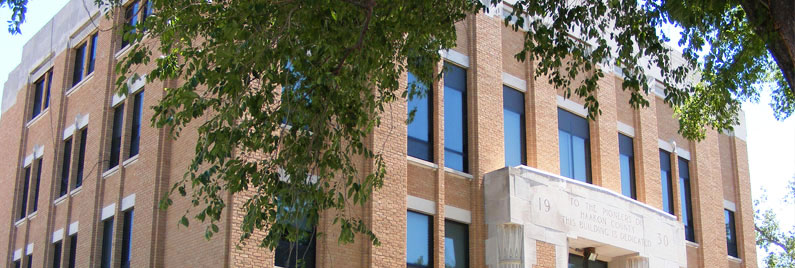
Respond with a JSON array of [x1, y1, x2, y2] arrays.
[[0, 0, 756, 268]]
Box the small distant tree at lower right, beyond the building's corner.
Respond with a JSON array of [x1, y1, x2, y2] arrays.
[[754, 177, 795, 268]]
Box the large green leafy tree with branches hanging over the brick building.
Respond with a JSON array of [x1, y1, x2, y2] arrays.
[[0, 0, 795, 253]]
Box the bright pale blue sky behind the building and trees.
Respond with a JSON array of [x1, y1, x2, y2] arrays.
[[0, 0, 795, 264]]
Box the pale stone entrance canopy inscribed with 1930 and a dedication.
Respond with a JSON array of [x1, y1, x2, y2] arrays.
[[484, 166, 687, 268]]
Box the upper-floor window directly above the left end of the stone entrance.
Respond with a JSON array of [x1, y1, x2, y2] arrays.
[[502, 86, 527, 167]]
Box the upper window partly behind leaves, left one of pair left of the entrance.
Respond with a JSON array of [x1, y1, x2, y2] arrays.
[[407, 73, 433, 162]]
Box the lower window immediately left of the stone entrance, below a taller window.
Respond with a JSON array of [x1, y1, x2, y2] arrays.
[[444, 220, 469, 268]]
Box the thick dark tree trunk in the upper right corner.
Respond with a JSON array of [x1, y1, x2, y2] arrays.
[[740, 0, 795, 94]]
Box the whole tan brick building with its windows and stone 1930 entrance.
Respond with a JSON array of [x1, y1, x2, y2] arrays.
[[0, 0, 756, 268]]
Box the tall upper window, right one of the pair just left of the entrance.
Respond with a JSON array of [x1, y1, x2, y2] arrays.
[[444, 63, 469, 173]]
